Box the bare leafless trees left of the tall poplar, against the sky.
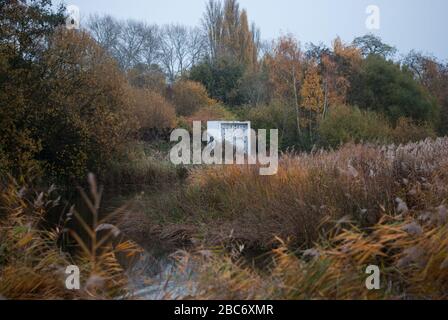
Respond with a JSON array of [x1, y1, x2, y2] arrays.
[[87, 15, 205, 82]]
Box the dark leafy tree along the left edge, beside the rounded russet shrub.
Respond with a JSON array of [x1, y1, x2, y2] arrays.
[[0, 0, 64, 175]]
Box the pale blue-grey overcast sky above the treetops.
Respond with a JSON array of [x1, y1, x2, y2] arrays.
[[56, 0, 448, 60]]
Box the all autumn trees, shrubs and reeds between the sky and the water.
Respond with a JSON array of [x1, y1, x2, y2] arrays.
[[0, 0, 448, 299]]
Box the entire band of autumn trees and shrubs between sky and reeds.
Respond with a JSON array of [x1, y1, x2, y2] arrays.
[[0, 0, 448, 184]]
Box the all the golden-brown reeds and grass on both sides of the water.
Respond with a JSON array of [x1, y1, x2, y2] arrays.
[[0, 138, 448, 299]]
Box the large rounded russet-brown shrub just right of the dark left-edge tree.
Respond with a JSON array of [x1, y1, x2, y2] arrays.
[[40, 28, 136, 182]]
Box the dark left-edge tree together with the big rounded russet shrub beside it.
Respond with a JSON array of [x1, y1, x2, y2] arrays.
[[0, 1, 140, 181]]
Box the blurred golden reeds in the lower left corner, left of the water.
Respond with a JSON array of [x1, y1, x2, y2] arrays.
[[0, 176, 140, 299]]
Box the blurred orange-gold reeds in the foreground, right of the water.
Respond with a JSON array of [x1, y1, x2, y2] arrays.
[[186, 205, 448, 300]]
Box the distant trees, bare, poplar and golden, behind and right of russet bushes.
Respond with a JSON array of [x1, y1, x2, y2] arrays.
[[87, 0, 448, 149]]
